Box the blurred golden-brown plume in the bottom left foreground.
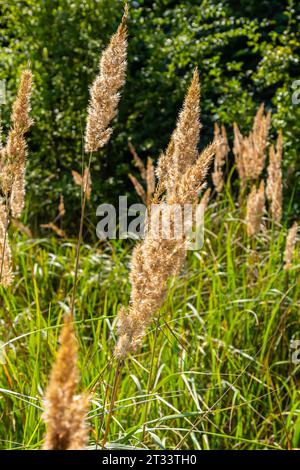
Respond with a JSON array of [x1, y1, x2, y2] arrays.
[[43, 315, 88, 450]]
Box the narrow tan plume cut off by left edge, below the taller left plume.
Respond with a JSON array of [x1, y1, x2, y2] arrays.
[[0, 203, 13, 287]]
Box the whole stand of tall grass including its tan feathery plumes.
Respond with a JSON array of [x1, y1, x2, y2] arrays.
[[0, 5, 300, 450]]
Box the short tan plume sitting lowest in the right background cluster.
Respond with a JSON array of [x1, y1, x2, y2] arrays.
[[246, 180, 265, 237]]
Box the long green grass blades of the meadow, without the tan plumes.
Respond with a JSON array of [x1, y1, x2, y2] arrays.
[[0, 192, 300, 449]]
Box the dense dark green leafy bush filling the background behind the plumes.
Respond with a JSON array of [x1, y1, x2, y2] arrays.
[[0, 0, 300, 231]]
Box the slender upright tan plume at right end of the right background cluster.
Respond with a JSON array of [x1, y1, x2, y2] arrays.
[[266, 131, 283, 223]]
